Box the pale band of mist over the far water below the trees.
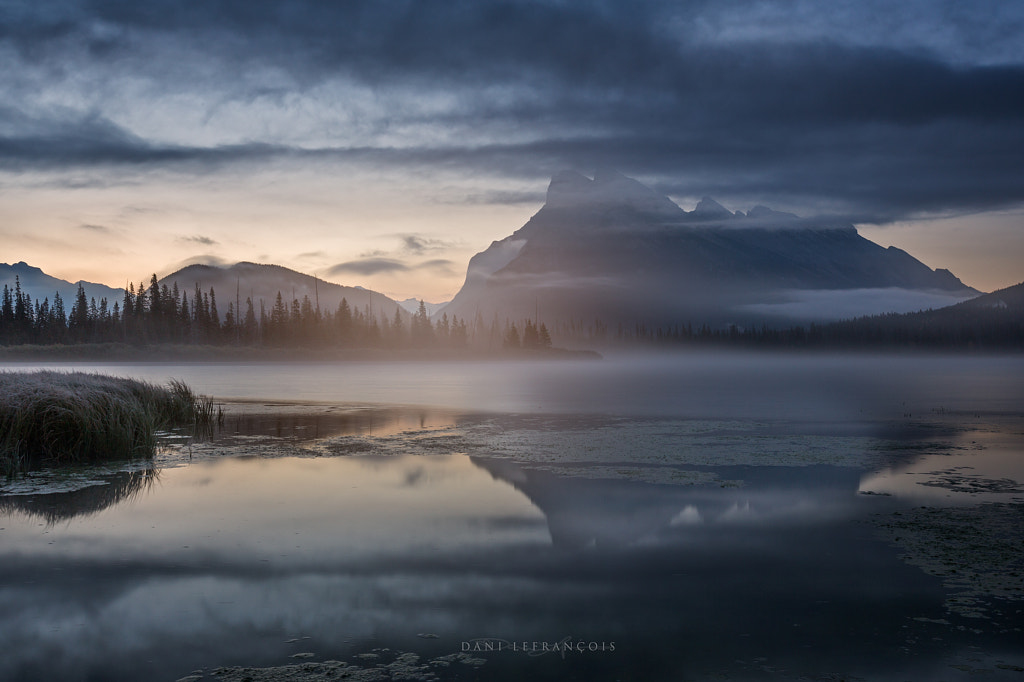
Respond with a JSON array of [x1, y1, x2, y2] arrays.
[[6, 352, 1024, 419]]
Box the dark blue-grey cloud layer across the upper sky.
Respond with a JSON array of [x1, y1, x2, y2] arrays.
[[0, 0, 1024, 220]]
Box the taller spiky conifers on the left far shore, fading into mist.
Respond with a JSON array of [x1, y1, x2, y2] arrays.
[[0, 274, 551, 349]]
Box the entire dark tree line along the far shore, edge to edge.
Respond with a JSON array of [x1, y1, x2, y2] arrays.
[[0, 274, 1011, 351]]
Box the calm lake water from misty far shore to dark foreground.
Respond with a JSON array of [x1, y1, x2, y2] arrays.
[[0, 355, 1024, 680]]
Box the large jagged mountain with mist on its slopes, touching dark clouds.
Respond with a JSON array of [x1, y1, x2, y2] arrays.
[[443, 171, 978, 325]]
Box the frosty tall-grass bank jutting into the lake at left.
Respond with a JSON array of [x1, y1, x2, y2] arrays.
[[0, 372, 216, 475]]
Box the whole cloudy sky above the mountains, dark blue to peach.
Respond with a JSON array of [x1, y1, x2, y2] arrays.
[[0, 0, 1024, 301]]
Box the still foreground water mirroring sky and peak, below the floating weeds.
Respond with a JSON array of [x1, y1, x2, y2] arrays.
[[0, 448, 983, 680]]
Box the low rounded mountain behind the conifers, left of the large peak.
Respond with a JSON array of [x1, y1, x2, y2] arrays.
[[160, 262, 409, 319]]
